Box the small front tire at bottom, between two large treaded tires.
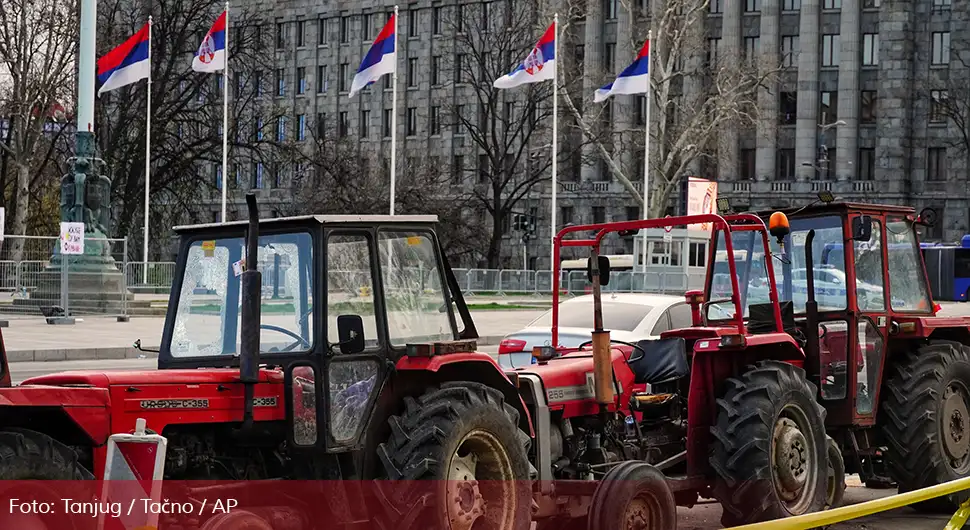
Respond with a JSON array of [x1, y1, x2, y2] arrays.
[[587, 461, 677, 530]]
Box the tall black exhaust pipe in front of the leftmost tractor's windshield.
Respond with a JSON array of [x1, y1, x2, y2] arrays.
[[239, 192, 263, 429]]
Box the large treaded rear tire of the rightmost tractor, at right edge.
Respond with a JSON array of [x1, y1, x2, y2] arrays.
[[881, 341, 970, 512]]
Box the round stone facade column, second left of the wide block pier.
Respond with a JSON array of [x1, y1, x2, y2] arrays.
[[795, 0, 816, 181]]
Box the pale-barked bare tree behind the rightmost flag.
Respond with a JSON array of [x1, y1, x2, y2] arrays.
[[564, 0, 778, 217]]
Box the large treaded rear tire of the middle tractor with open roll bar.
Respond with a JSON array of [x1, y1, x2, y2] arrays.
[[711, 361, 828, 526]]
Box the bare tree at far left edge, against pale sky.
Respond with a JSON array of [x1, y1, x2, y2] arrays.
[[0, 0, 78, 260]]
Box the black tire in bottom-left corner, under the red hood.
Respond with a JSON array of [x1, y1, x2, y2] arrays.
[[0, 429, 94, 530]]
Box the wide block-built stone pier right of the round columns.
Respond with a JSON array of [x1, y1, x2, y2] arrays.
[[876, 0, 917, 192]]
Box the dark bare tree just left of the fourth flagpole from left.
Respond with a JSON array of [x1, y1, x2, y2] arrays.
[[441, 0, 584, 268]]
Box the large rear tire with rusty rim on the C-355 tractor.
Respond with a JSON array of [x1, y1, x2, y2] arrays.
[[377, 381, 532, 530]]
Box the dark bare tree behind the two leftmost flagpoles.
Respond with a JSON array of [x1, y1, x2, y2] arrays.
[[97, 0, 283, 256]]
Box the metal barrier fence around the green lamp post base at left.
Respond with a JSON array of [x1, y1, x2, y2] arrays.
[[0, 235, 132, 316]]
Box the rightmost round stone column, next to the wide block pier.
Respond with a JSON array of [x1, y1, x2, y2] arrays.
[[827, 0, 860, 182]]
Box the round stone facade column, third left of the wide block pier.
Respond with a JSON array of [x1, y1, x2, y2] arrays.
[[755, 2, 781, 181]]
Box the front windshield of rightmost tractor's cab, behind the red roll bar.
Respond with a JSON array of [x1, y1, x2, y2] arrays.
[[708, 216, 846, 320]]
